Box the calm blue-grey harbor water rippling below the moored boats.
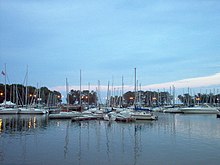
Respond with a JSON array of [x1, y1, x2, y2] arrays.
[[0, 113, 220, 165]]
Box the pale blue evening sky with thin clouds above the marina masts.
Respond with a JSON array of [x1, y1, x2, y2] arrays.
[[0, 0, 220, 100]]
